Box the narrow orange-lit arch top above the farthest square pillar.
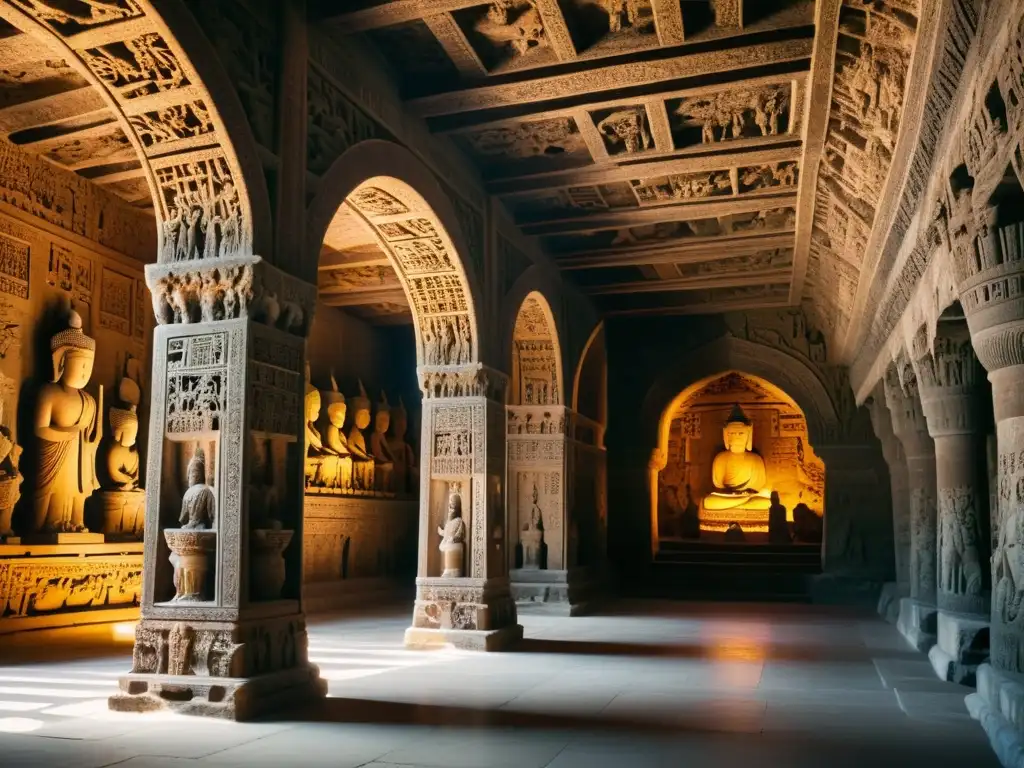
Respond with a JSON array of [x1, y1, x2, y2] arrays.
[[508, 291, 564, 406]]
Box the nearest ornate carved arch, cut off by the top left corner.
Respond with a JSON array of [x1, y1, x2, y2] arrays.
[[0, 0, 272, 262]]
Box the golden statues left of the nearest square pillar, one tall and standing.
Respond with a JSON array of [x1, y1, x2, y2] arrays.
[[9, 309, 148, 536]]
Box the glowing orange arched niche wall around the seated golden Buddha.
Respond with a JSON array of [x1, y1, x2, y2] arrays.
[[649, 371, 825, 542]]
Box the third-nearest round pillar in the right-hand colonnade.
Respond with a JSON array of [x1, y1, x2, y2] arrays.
[[885, 359, 938, 653]]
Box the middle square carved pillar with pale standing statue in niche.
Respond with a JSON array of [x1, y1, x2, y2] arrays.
[[406, 364, 522, 650]]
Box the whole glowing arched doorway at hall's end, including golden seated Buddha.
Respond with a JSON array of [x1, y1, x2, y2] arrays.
[[650, 371, 825, 550]]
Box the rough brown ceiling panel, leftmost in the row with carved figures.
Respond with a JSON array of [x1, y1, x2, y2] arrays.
[[455, 117, 592, 173]]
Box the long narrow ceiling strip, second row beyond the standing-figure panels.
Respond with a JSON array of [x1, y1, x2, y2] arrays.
[[544, 207, 797, 253]]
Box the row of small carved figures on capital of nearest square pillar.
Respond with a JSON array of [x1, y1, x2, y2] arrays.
[[153, 264, 306, 332]]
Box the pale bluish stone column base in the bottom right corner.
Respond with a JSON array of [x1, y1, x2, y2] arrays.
[[965, 664, 1024, 768]]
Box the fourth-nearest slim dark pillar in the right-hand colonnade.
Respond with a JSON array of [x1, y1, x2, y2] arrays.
[[867, 386, 910, 624]]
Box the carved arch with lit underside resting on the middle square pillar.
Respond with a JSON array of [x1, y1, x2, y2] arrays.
[[299, 139, 481, 366]]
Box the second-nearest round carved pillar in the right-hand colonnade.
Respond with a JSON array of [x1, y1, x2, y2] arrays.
[[912, 321, 991, 683]]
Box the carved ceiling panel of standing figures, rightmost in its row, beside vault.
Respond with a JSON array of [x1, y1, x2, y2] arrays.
[[666, 83, 792, 150]]
